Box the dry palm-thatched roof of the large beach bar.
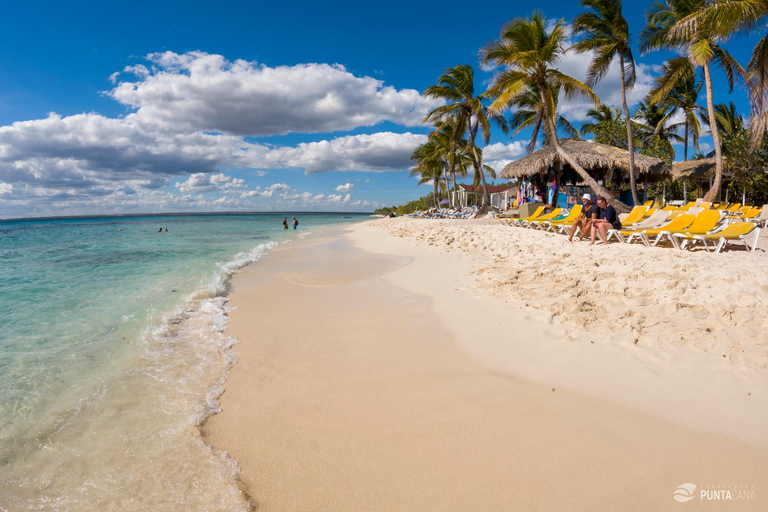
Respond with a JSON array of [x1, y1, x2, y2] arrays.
[[500, 139, 671, 179]]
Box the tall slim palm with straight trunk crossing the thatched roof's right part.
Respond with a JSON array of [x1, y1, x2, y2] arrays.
[[573, 0, 638, 204]]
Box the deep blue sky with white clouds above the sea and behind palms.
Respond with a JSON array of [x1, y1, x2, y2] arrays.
[[0, 0, 752, 218]]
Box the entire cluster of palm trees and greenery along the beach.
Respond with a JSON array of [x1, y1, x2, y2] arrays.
[[400, 0, 768, 214]]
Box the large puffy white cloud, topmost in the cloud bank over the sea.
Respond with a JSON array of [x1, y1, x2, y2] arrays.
[[107, 51, 440, 136]]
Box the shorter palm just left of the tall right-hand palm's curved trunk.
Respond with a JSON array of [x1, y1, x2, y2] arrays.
[[651, 57, 704, 160]]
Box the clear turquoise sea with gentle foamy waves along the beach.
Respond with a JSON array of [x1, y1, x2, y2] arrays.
[[0, 215, 364, 511]]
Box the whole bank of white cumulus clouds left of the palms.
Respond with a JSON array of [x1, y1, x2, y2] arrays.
[[0, 52, 434, 216]]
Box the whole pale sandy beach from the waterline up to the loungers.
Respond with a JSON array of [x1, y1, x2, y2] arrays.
[[204, 219, 768, 511]]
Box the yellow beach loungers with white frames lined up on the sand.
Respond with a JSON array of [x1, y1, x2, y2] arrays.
[[500, 202, 768, 253]]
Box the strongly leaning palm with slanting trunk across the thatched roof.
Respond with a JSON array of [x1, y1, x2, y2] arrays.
[[480, 12, 628, 211]]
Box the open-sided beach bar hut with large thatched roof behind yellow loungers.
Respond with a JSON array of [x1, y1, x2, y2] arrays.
[[500, 139, 672, 208]]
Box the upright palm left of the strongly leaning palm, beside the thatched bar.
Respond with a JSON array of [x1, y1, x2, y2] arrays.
[[424, 64, 506, 208]]
